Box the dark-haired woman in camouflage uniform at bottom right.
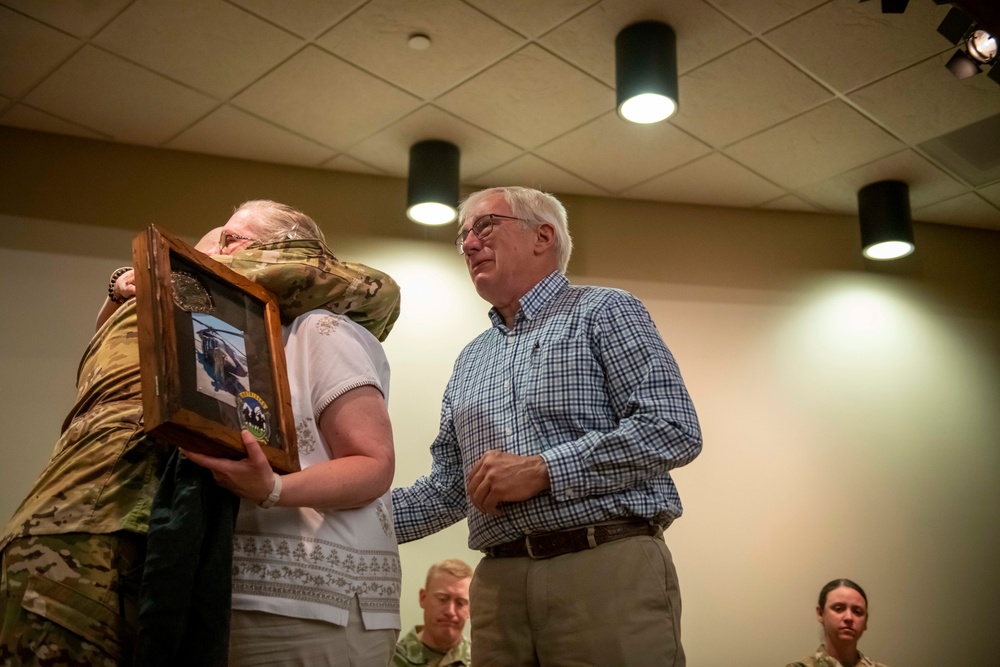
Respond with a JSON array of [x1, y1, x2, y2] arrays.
[[787, 579, 888, 667]]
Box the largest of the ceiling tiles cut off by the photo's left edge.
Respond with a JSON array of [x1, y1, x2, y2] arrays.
[[0, 7, 80, 98]]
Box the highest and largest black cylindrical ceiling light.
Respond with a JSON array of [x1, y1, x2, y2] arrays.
[[615, 21, 677, 123]]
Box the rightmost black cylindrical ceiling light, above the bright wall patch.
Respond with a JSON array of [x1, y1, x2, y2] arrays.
[[858, 181, 914, 260]]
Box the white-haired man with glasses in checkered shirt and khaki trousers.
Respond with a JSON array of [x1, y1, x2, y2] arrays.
[[393, 187, 701, 667]]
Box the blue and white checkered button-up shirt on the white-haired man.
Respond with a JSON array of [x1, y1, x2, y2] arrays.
[[392, 272, 701, 549]]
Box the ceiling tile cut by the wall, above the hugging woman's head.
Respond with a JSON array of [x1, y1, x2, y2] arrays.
[[166, 106, 334, 167]]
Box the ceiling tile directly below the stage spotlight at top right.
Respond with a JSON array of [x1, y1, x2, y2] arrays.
[[848, 51, 1000, 144]]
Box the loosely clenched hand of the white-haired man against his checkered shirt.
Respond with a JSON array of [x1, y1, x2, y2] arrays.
[[468, 449, 549, 514]]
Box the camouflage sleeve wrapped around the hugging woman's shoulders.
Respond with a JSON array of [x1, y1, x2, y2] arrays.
[[212, 240, 400, 341]]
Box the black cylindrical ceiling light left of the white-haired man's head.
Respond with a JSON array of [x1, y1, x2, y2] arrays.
[[406, 139, 459, 225]]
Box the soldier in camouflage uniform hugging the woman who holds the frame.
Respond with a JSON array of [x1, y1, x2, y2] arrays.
[[0, 202, 399, 667]]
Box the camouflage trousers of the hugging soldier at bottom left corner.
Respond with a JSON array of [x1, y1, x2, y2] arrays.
[[0, 533, 145, 667]]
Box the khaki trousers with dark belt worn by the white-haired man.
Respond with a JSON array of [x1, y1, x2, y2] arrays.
[[470, 537, 685, 667]]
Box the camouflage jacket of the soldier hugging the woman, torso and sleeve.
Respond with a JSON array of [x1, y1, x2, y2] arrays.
[[0, 241, 399, 548]]
